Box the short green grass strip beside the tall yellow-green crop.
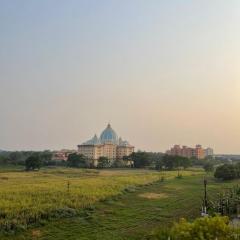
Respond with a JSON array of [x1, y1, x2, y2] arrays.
[[1, 170, 237, 240]]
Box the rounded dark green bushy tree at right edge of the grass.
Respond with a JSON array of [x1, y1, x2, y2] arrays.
[[214, 164, 237, 180]]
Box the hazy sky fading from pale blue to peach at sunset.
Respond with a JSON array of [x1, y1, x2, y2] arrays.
[[0, 0, 240, 154]]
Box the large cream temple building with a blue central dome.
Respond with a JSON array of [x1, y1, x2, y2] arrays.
[[78, 124, 134, 165]]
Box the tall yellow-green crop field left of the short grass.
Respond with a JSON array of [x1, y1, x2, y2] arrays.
[[0, 168, 202, 231]]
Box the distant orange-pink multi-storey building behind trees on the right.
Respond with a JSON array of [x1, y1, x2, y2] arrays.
[[166, 145, 213, 159]]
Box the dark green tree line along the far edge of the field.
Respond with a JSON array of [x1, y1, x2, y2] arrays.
[[0, 151, 218, 171]]
